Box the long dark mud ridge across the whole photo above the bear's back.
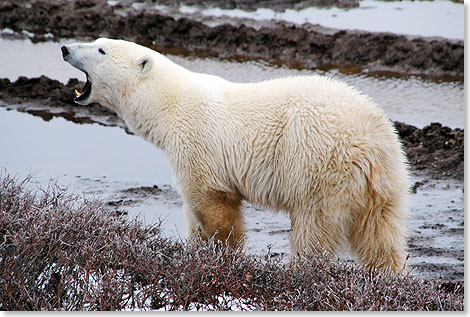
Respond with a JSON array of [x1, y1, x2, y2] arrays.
[[0, 0, 464, 80]]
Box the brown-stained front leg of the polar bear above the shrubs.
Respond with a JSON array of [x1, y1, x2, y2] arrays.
[[183, 191, 244, 247]]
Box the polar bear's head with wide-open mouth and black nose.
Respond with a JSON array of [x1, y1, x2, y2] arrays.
[[61, 38, 156, 112]]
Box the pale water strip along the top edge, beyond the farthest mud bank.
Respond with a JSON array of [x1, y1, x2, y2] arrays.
[[151, 0, 464, 40]]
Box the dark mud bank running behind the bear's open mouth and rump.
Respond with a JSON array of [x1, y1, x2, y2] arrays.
[[0, 76, 464, 180]]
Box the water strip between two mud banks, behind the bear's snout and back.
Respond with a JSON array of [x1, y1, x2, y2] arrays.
[[0, 38, 464, 128]]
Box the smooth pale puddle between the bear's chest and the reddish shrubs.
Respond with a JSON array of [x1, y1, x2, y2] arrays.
[[0, 108, 172, 188]]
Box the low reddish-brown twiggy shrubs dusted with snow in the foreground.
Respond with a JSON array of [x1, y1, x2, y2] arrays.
[[0, 175, 464, 311]]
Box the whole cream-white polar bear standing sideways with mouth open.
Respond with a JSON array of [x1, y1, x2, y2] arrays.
[[61, 38, 409, 272]]
